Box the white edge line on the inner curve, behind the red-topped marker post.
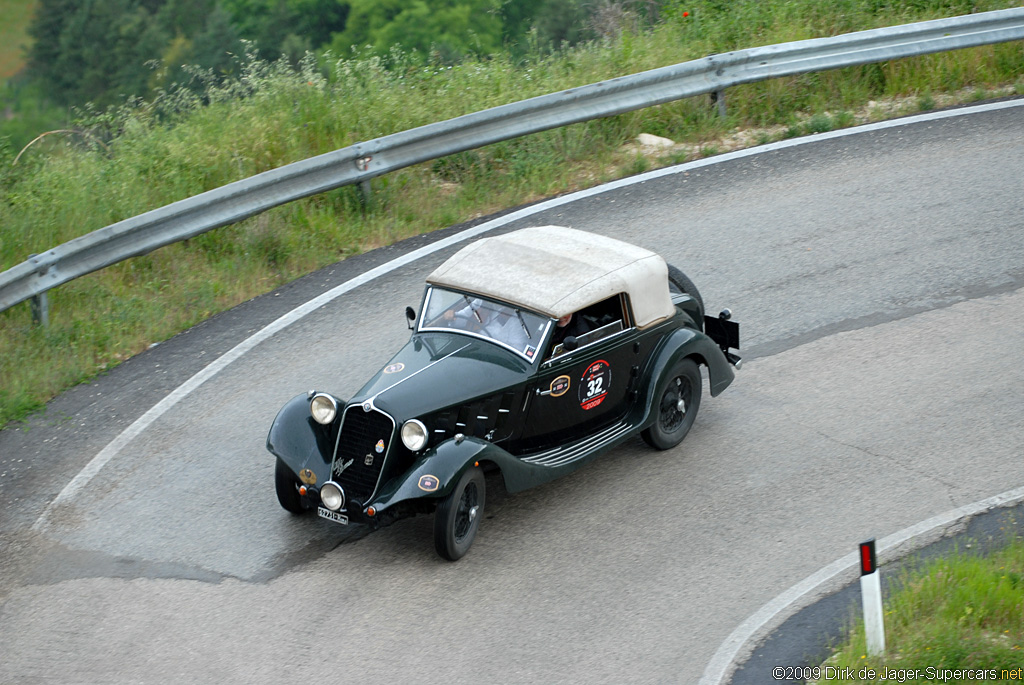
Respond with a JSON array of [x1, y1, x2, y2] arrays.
[[698, 487, 1024, 685]]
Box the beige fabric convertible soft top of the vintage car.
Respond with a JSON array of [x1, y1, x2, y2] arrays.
[[427, 226, 675, 328]]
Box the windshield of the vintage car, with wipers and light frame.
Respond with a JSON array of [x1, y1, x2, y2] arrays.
[[420, 288, 551, 361]]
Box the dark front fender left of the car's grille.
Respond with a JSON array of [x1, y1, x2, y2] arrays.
[[266, 394, 344, 487]]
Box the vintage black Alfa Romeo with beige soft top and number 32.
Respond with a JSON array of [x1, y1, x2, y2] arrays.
[[267, 226, 740, 560]]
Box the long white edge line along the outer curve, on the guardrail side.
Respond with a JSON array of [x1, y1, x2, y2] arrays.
[[32, 94, 1024, 532]]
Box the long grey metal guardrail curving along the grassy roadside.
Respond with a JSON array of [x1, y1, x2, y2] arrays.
[[6, 7, 1024, 317]]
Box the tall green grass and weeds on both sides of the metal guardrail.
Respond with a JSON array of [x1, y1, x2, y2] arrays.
[[0, 0, 1024, 426]]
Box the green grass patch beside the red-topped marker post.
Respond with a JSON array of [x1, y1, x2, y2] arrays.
[[818, 538, 1024, 685]]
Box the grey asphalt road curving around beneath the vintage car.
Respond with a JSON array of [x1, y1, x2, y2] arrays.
[[0, 98, 1024, 683]]
